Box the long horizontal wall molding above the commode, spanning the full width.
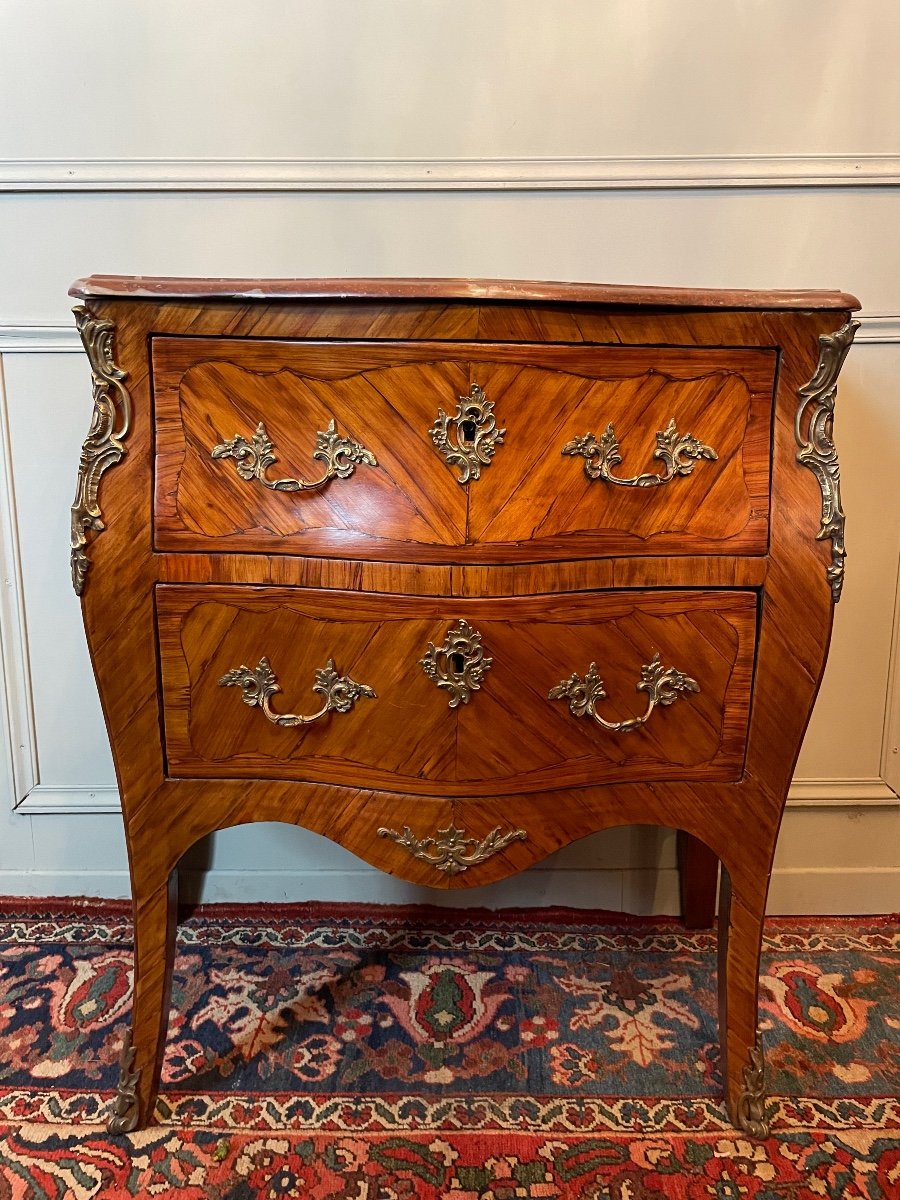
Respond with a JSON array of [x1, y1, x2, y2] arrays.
[[0, 154, 900, 192]]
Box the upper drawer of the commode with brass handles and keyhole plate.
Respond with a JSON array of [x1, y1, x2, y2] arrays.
[[152, 337, 776, 562]]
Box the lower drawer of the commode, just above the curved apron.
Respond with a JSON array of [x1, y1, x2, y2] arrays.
[[157, 584, 757, 796]]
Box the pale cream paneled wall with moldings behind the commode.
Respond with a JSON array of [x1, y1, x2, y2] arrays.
[[0, 0, 900, 912]]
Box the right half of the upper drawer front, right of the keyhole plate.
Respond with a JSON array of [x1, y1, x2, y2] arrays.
[[469, 347, 775, 558]]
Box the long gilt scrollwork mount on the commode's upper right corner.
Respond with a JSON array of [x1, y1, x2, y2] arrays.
[[793, 320, 859, 604]]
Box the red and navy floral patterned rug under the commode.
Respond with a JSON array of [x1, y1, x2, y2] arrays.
[[0, 901, 900, 1200]]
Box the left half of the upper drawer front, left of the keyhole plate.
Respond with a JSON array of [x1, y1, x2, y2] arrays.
[[152, 338, 468, 559]]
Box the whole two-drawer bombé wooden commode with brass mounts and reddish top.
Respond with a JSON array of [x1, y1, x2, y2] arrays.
[[72, 276, 858, 1135]]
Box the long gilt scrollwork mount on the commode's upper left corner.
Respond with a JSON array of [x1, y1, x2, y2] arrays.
[[70, 305, 131, 595]]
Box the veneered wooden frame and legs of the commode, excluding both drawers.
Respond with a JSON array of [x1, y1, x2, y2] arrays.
[[70, 281, 856, 1123]]
